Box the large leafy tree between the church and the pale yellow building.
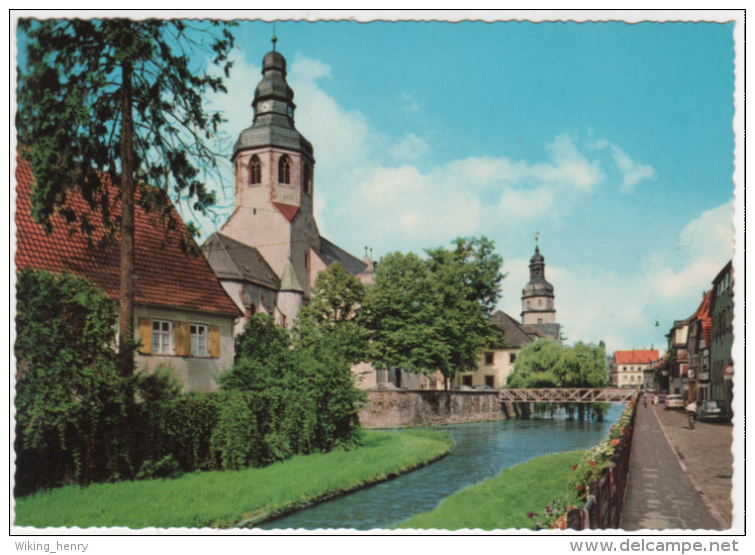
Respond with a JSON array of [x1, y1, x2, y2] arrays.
[[361, 237, 503, 389]]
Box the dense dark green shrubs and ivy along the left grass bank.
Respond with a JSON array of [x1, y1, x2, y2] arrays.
[[14, 270, 364, 497]]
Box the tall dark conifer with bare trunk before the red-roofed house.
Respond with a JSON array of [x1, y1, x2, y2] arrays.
[[16, 19, 234, 375]]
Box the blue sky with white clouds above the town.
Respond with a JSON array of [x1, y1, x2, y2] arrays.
[[14, 17, 734, 358]]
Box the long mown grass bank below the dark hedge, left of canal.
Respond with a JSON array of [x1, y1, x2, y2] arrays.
[[15, 430, 453, 528]]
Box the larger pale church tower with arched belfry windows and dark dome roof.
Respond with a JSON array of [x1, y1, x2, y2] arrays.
[[222, 37, 321, 298]]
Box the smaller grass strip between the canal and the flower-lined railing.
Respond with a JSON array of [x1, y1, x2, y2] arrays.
[[399, 451, 585, 530]]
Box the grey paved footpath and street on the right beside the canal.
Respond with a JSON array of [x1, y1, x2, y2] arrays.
[[621, 404, 732, 530]]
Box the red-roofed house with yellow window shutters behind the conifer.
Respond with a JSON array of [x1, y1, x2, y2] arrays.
[[15, 157, 241, 391]]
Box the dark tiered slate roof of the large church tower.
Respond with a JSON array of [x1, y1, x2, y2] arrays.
[[233, 50, 312, 158]]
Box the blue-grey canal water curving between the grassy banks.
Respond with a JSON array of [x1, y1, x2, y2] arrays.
[[259, 403, 625, 530]]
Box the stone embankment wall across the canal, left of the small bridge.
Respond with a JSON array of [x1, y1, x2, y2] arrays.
[[359, 390, 513, 428]]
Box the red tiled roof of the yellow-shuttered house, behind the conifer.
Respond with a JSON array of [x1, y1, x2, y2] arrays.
[[15, 157, 241, 316]]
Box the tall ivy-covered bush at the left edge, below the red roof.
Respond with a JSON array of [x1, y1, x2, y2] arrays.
[[15, 269, 128, 491]]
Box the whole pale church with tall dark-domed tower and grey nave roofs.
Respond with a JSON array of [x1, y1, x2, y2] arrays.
[[202, 44, 373, 332]]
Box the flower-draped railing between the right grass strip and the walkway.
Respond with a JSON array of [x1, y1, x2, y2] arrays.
[[566, 390, 638, 530]]
